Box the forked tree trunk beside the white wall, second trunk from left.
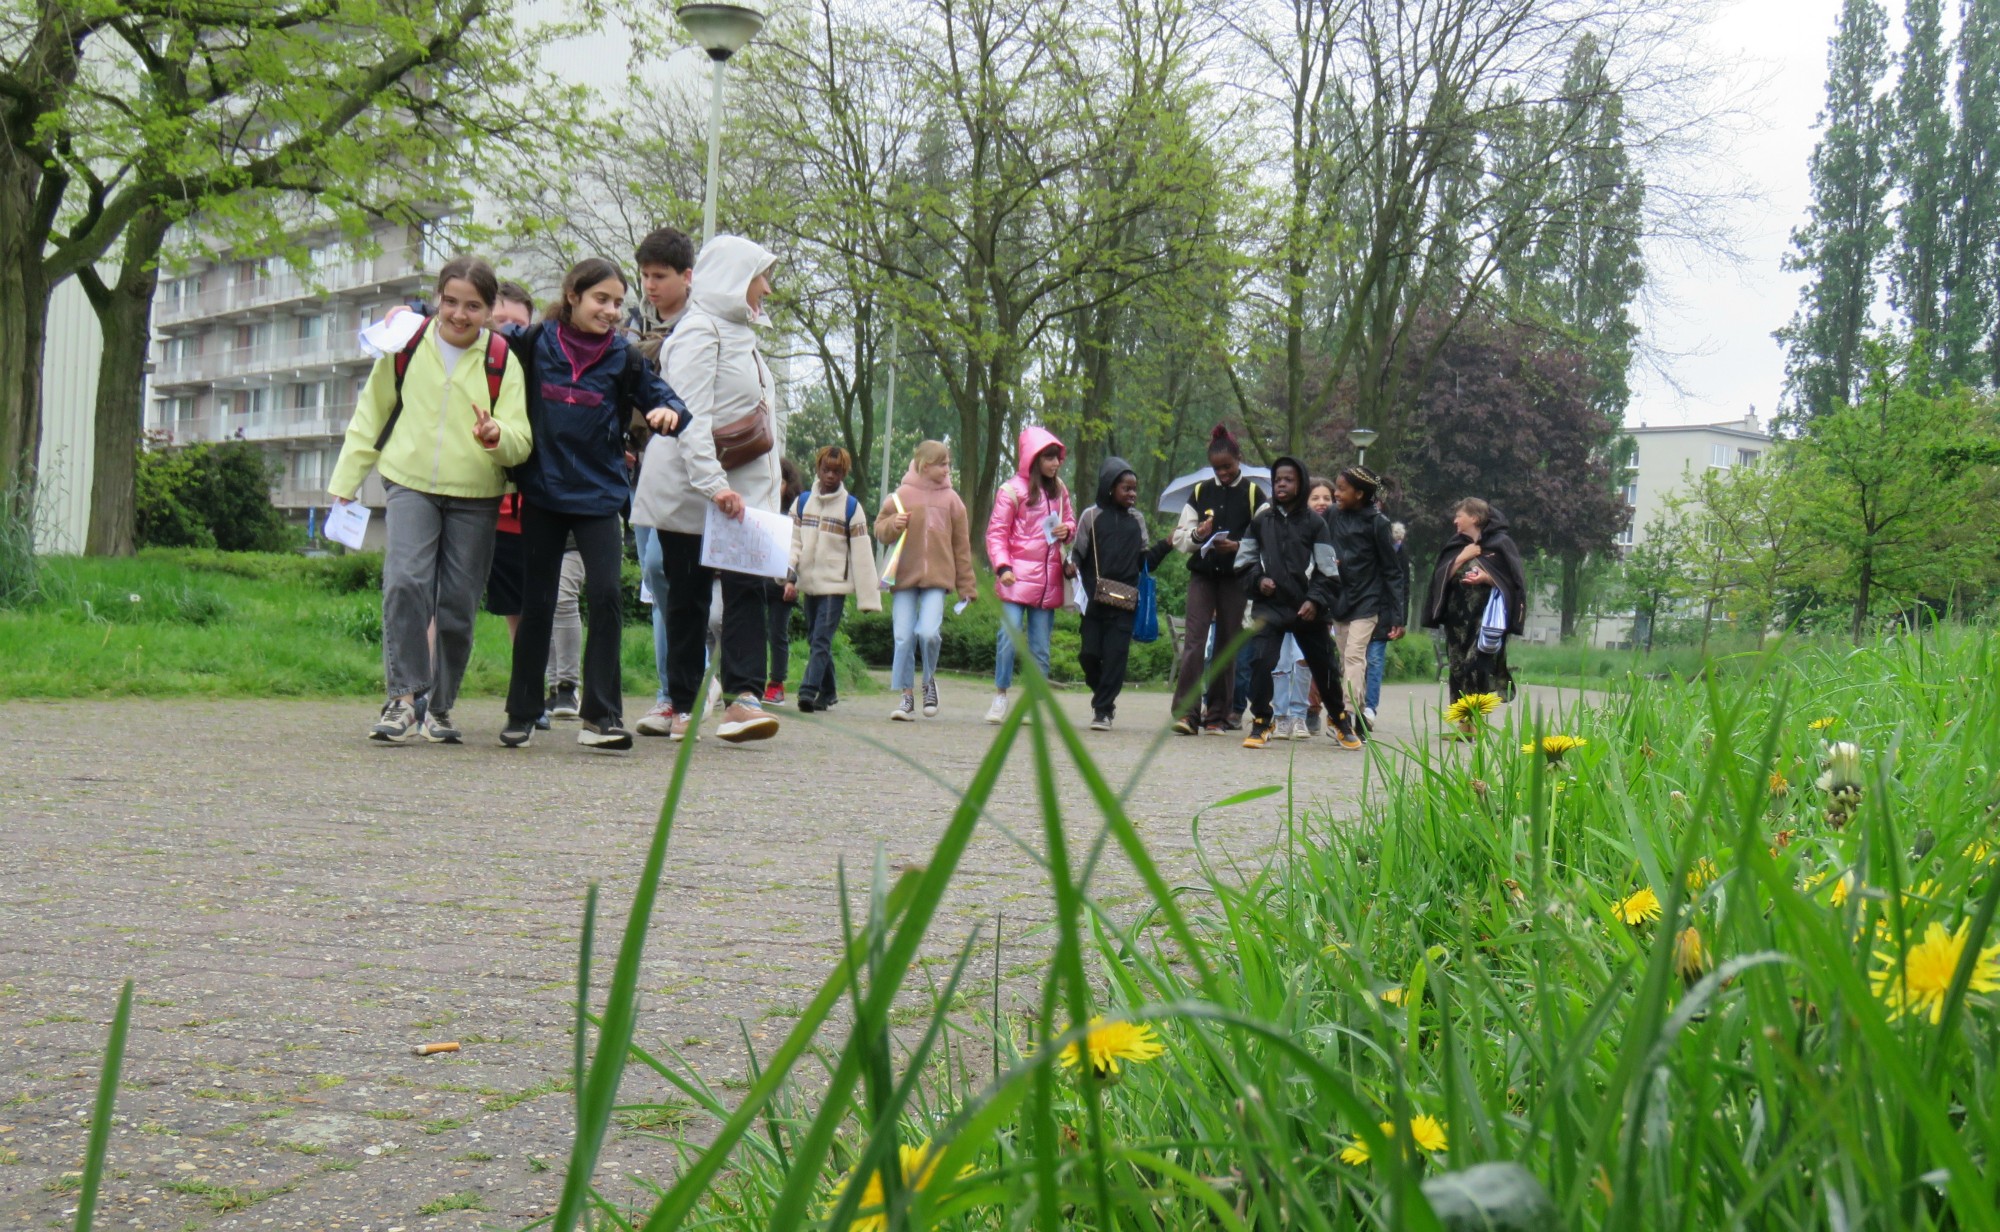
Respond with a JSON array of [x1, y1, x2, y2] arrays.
[[78, 210, 168, 556]]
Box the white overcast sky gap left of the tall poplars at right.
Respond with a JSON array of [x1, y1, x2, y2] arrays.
[[1626, 0, 1840, 424]]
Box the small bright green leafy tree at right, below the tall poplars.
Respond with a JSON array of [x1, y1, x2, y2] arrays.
[[1790, 340, 1996, 642]]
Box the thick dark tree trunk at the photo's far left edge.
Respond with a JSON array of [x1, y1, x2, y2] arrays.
[[0, 166, 50, 508]]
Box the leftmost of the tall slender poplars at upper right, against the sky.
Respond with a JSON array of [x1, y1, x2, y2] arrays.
[[1778, 0, 1890, 416]]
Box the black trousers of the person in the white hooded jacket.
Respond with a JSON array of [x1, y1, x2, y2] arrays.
[[660, 530, 768, 714]]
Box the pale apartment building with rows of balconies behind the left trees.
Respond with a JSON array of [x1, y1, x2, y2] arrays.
[[146, 226, 444, 518]]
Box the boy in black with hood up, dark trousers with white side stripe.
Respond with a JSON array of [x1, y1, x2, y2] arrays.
[[1236, 458, 1362, 748]]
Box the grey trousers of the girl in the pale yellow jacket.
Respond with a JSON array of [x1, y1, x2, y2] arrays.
[[382, 484, 500, 714]]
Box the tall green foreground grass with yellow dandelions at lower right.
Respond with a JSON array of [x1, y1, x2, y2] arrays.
[[47, 630, 2000, 1232]]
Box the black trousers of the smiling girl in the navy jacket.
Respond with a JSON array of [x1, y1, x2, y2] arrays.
[[506, 502, 624, 724]]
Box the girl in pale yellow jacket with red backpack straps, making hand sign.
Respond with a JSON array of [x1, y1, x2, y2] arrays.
[[326, 256, 532, 744]]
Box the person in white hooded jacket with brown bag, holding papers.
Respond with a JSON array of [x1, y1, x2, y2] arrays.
[[632, 236, 784, 742]]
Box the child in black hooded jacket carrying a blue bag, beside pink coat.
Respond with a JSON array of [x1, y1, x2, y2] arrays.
[[1070, 458, 1174, 732]]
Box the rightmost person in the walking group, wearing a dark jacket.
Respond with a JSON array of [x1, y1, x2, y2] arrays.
[[1424, 496, 1528, 702]]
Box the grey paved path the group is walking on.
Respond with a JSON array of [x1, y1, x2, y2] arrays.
[[0, 684, 1560, 1232]]
